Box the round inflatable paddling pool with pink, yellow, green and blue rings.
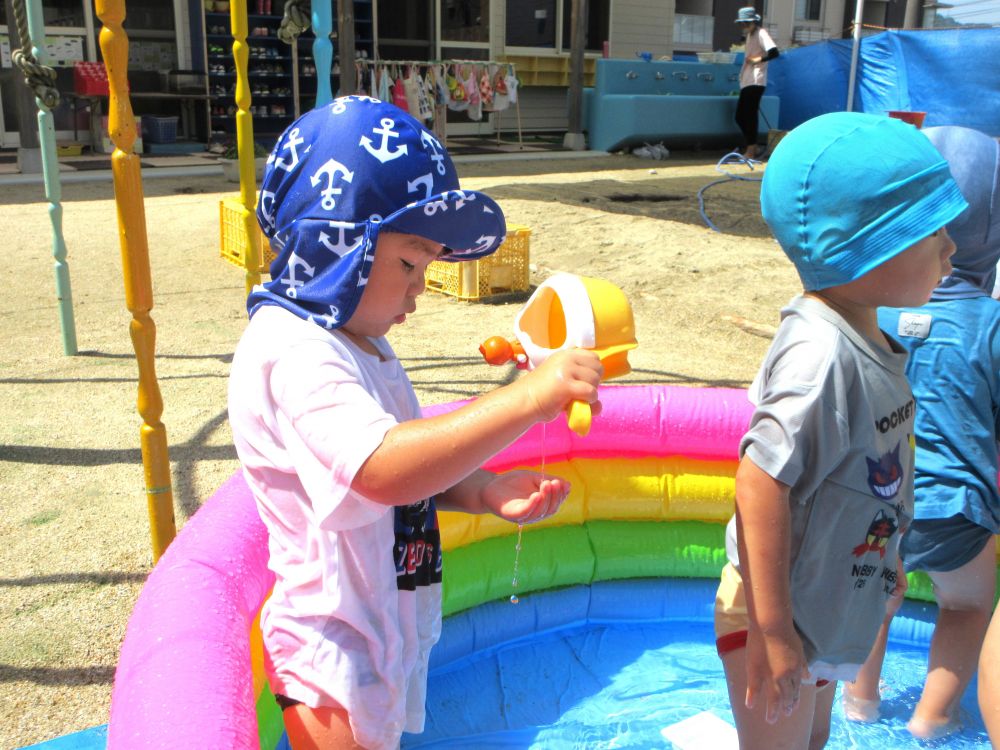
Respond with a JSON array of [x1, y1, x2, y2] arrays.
[[108, 386, 992, 750]]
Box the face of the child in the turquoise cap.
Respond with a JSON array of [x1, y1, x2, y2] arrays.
[[843, 227, 955, 307]]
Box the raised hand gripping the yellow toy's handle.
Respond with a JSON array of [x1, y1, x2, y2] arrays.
[[518, 349, 604, 422]]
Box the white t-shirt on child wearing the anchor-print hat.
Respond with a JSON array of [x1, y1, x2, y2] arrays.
[[229, 306, 441, 748]]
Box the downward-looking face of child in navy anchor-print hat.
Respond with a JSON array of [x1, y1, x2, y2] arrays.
[[343, 232, 443, 337]]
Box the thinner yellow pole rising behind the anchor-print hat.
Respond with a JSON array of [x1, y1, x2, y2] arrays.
[[229, 0, 260, 295]]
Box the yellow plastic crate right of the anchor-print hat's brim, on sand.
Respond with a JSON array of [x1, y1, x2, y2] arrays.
[[424, 226, 531, 300]]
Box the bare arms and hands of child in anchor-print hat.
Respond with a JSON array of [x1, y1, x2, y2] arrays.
[[351, 349, 602, 508]]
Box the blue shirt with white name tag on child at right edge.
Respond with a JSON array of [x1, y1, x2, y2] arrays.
[[878, 294, 1000, 534]]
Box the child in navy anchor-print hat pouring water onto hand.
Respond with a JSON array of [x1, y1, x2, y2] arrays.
[[229, 97, 601, 750]]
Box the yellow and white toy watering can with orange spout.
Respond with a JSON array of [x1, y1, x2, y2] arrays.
[[479, 273, 637, 436]]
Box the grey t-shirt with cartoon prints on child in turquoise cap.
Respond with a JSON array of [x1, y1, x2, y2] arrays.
[[727, 296, 915, 680]]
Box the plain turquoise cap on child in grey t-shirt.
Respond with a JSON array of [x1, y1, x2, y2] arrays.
[[760, 112, 967, 291]]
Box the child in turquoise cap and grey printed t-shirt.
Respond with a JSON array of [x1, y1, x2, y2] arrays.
[[716, 113, 965, 750]]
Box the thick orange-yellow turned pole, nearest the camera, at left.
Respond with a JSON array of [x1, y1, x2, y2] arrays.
[[94, 0, 177, 562]]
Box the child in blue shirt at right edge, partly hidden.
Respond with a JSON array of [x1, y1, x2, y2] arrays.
[[844, 126, 1000, 739]]
